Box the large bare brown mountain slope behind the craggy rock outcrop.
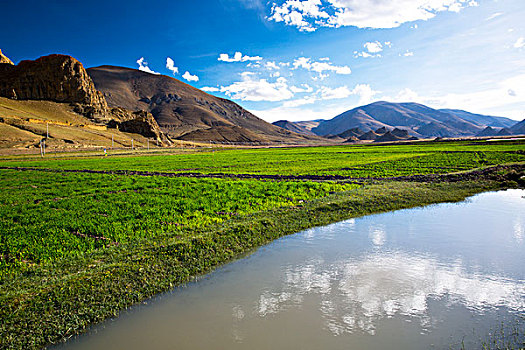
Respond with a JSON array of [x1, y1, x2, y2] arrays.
[[87, 66, 321, 143]]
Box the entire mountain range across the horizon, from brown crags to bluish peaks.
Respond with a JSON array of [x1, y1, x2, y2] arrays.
[[0, 51, 525, 148]]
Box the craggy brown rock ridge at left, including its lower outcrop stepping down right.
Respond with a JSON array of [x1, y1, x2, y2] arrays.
[[0, 51, 169, 142]]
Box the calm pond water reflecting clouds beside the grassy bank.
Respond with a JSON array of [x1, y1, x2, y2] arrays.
[[57, 190, 525, 349]]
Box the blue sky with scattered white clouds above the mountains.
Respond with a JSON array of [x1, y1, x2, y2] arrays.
[[0, 0, 525, 122]]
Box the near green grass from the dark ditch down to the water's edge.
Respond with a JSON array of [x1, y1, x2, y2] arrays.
[[0, 141, 525, 349]]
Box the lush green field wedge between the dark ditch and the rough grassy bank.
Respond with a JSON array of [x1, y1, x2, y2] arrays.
[[0, 171, 357, 276]]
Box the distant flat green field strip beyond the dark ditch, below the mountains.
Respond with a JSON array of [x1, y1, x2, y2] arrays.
[[0, 140, 525, 177]]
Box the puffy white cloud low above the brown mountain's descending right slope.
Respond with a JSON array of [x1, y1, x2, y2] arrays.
[[220, 72, 293, 101]]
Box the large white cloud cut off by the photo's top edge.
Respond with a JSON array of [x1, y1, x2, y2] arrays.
[[268, 0, 478, 32]]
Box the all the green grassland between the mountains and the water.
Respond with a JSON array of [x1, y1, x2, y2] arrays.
[[0, 142, 525, 349]]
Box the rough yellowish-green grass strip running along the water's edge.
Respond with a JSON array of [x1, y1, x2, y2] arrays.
[[0, 165, 524, 349]]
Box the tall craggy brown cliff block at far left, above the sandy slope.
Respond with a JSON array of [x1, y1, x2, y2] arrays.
[[0, 55, 108, 118]]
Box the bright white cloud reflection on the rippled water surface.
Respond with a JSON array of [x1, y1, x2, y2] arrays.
[[252, 252, 525, 335]]
